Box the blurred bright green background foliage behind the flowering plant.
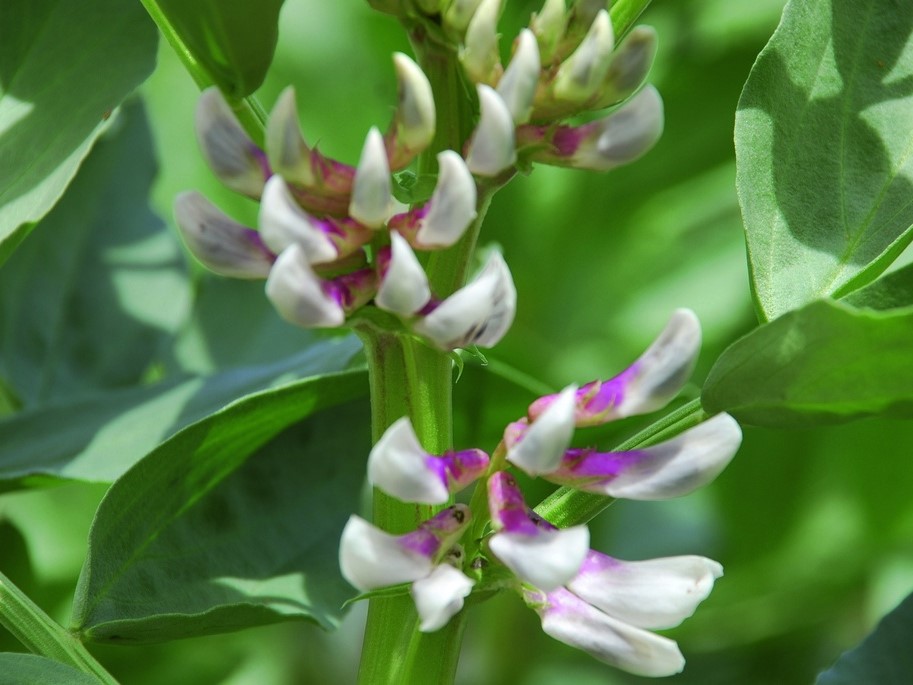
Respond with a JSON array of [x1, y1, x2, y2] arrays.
[[0, 0, 913, 685]]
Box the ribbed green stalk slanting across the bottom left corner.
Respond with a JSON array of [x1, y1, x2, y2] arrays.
[[0, 572, 117, 685]]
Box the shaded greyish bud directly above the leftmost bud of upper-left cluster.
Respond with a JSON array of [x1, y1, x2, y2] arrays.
[[195, 86, 266, 198]]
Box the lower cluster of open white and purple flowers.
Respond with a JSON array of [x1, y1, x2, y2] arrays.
[[340, 310, 741, 676]]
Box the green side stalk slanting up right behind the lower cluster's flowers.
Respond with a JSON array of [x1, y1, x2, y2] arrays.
[[535, 399, 707, 528]]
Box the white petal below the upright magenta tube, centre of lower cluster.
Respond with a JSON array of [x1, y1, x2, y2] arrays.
[[488, 526, 590, 592]]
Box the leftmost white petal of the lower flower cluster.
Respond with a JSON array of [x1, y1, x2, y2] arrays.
[[339, 515, 432, 592]]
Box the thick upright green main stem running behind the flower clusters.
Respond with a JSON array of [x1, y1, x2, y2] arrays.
[[358, 17, 490, 685]]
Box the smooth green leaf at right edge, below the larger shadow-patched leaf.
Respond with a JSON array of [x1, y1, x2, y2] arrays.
[[701, 300, 913, 426]]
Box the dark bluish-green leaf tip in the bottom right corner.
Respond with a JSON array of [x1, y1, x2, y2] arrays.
[[815, 595, 913, 685]]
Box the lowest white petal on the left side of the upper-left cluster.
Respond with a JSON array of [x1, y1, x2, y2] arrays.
[[266, 245, 346, 328]]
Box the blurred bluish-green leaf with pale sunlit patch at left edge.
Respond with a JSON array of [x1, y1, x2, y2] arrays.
[[0, 97, 190, 407]]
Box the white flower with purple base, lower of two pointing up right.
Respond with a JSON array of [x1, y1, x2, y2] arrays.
[[545, 414, 742, 500]]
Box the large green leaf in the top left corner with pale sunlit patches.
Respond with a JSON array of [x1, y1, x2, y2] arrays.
[[0, 0, 157, 264]]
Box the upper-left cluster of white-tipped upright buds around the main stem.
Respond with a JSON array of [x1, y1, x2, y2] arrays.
[[175, 54, 516, 350]]
